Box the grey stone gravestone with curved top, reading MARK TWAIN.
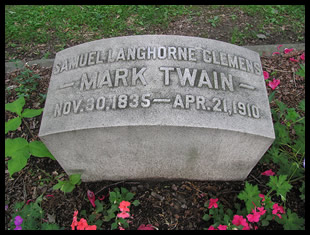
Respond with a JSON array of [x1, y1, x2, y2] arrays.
[[39, 35, 275, 181]]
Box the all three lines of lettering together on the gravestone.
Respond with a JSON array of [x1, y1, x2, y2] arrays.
[[53, 40, 262, 125]]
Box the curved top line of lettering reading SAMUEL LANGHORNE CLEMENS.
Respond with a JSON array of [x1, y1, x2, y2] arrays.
[[53, 46, 262, 75]]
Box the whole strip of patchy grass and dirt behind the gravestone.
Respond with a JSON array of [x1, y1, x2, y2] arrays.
[[5, 5, 305, 59]]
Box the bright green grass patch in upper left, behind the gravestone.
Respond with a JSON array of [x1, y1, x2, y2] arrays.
[[5, 5, 189, 47]]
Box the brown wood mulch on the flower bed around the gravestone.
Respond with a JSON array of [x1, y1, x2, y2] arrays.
[[5, 51, 305, 230]]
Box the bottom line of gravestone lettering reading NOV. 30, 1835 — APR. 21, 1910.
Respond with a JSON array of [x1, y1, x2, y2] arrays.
[[54, 93, 260, 119]]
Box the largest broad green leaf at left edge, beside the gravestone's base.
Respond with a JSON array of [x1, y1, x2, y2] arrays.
[[5, 138, 30, 177]]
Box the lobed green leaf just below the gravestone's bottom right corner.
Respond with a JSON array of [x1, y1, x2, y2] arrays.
[[238, 181, 261, 213]]
